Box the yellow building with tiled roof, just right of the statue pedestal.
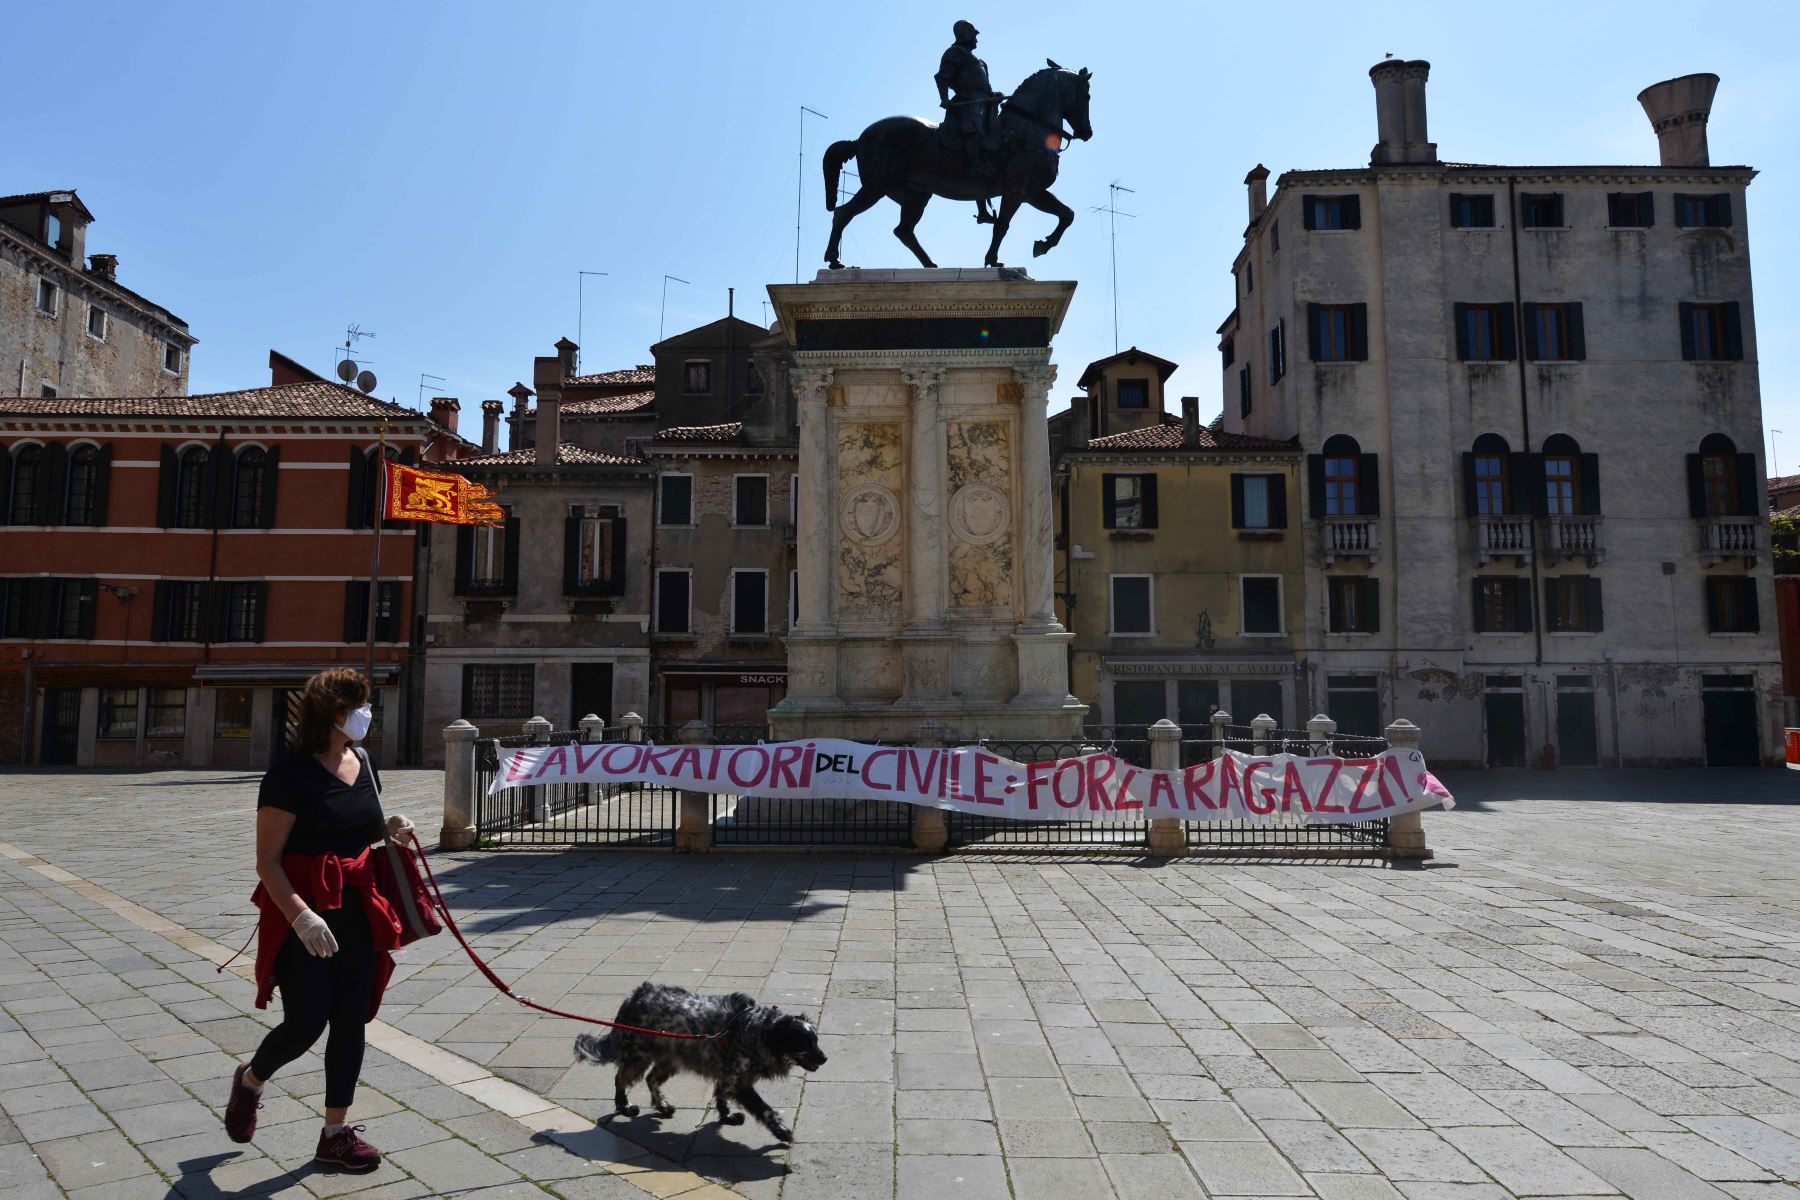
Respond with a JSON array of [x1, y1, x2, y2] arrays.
[[1051, 347, 1307, 729]]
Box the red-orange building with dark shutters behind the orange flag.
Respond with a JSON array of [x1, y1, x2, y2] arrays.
[[0, 368, 430, 768]]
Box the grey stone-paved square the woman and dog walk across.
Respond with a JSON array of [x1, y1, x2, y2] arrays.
[[0, 772, 1800, 1200]]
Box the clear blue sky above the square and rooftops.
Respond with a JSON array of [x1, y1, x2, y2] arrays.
[[14, 0, 1800, 456]]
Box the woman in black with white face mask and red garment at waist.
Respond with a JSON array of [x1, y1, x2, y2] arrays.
[[225, 669, 412, 1171]]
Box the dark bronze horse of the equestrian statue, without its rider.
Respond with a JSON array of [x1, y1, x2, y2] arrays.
[[824, 59, 1094, 270]]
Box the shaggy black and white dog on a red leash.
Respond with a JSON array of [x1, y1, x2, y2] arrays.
[[574, 982, 824, 1142]]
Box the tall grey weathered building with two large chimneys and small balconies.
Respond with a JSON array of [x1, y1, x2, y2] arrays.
[[1220, 61, 1780, 765]]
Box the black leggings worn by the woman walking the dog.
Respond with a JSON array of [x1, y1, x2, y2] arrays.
[[250, 887, 374, 1108]]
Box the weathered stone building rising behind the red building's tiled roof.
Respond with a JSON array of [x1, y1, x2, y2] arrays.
[[0, 189, 194, 398]]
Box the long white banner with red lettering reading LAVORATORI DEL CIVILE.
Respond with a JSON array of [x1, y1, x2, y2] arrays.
[[490, 738, 1454, 824]]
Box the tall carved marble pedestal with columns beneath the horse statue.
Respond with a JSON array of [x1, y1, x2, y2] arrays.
[[769, 268, 1087, 741]]
